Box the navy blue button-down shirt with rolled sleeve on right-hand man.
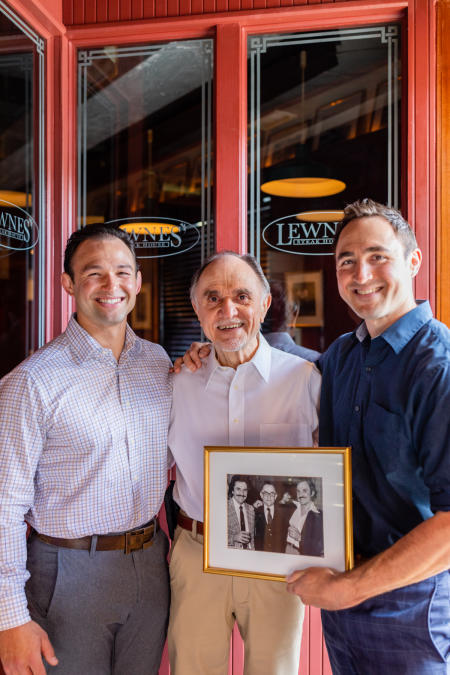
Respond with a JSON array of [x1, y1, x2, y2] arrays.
[[318, 302, 450, 556]]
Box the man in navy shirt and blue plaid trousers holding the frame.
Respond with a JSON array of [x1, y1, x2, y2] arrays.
[[288, 200, 450, 675]]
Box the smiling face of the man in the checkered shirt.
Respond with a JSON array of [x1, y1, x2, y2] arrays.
[[62, 237, 141, 336]]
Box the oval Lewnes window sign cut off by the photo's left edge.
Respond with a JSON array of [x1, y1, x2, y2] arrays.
[[0, 199, 39, 251]]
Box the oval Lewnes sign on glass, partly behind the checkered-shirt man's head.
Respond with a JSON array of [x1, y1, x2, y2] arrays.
[[107, 217, 200, 258]]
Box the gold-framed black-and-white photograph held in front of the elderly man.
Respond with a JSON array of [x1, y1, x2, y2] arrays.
[[203, 446, 353, 581]]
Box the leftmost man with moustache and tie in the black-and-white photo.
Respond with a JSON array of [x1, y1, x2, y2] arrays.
[[227, 476, 255, 550]]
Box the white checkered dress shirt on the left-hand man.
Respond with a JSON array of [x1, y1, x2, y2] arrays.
[[0, 317, 172, 630]]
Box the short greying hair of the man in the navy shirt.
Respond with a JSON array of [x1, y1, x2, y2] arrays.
[[334, 197, 417, 258]]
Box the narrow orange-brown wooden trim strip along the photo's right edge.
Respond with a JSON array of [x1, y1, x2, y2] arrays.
[[436, 0, 450, 326]]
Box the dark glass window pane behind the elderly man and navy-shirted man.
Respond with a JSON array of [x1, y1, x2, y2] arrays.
[[248, 25, 401, 351]]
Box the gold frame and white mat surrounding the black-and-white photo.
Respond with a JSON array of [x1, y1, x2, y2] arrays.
[[204, 447, 353, 581]]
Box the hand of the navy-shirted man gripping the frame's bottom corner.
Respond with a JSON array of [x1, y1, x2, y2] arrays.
[[286, 567, 361, 610]]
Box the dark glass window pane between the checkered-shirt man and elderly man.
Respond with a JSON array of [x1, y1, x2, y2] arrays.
[[78, 40, 214, 357]]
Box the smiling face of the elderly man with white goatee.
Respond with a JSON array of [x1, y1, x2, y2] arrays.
[[192, 255, 270, 367]]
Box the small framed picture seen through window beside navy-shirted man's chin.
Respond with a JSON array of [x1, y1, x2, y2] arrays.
[[285, 270, 323, 328]]
